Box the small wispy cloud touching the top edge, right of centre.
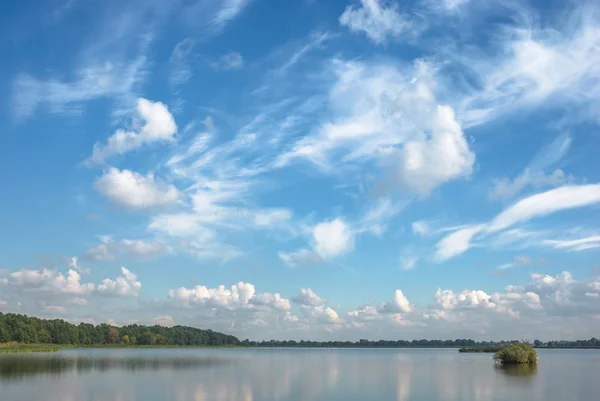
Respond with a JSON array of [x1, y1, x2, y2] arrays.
[[340, 0, 415, 44]]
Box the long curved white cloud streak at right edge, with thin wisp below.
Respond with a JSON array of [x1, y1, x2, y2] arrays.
[[435, 184, 600, 261]]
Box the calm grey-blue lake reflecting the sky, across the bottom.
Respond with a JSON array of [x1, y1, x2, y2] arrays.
[[0, 348, 600, 401]]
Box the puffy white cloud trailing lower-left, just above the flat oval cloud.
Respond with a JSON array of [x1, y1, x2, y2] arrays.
[[86, 98, 177, 164]]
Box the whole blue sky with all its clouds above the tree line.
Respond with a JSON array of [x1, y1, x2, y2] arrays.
[[0, 0, 600, 340]]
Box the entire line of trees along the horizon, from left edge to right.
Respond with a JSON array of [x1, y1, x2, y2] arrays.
[[0, 312, 600, 348]]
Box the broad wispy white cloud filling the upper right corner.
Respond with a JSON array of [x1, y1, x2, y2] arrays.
[[458, 5, 600, 126]]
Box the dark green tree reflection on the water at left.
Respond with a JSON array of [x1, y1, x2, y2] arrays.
[[0, 356, 226, 380]]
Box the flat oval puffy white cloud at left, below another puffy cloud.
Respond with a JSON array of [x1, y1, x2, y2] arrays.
[[94, 167, 181, 209]]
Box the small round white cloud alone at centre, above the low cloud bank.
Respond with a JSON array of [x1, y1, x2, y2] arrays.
[[313, 217, 354, 259]]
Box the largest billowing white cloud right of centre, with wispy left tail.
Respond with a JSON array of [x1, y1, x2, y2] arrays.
[[276, 59, 475, 196]]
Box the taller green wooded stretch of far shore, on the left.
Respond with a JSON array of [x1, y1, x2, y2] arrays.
[[0, 312, 240, 346]]
